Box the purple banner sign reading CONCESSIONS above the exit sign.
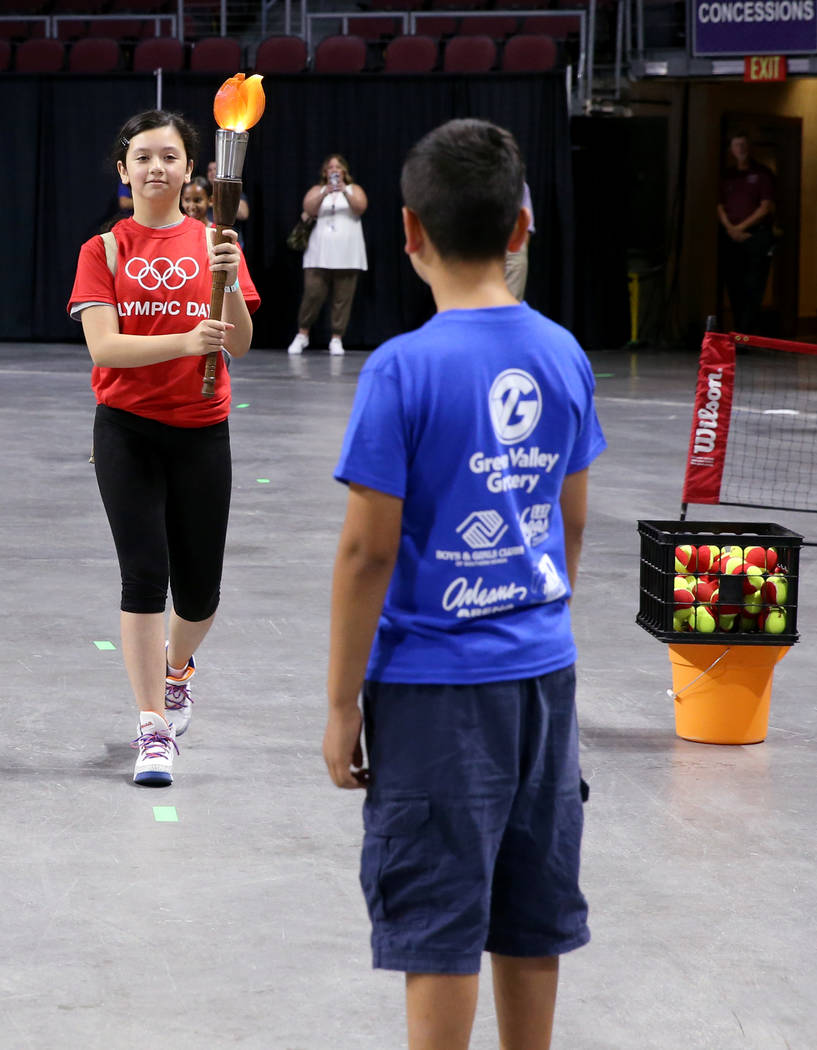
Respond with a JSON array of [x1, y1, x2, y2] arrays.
[[692, 0, 817, 56]]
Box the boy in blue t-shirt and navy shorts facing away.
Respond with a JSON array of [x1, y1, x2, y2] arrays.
[[323, 120, 605, 1050]]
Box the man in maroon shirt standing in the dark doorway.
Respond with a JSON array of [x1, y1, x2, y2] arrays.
[[717, 132, 774, 334]]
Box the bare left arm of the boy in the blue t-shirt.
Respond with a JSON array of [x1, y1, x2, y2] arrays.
[[323, 484, 403, 788]]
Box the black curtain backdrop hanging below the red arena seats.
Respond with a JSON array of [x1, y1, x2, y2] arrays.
[[0, 74, 574, 349]]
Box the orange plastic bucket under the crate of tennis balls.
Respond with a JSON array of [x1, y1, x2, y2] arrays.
[[669, 645, 791, 743]]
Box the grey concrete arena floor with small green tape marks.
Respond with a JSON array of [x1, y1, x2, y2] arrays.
[[0, 344, 817, 1050]]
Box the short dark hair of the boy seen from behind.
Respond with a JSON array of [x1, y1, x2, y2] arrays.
[[400, 120, 525, 261]]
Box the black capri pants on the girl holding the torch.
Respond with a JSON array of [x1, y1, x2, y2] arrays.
[[93, 404, 232, 623]]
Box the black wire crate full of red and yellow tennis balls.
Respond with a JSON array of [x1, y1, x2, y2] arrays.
[[635, 521, 803, 646]]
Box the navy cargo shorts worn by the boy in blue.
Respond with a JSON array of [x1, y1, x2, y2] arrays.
[[360, 666, 590, 973]]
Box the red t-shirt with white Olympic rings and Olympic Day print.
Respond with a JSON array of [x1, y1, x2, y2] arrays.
[[68, 216, 260, 426]]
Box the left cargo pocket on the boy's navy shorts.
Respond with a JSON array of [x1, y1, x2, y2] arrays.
[[360, 796, 432, 926]]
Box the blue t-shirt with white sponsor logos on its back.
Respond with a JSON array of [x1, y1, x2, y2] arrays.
[[335, 303, 605, 684]]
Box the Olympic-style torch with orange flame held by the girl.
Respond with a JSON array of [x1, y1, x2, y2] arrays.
[[202, 72, 266, 397]]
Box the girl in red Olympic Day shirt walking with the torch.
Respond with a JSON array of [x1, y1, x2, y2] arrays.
[[68, 110, 260, 784]]
